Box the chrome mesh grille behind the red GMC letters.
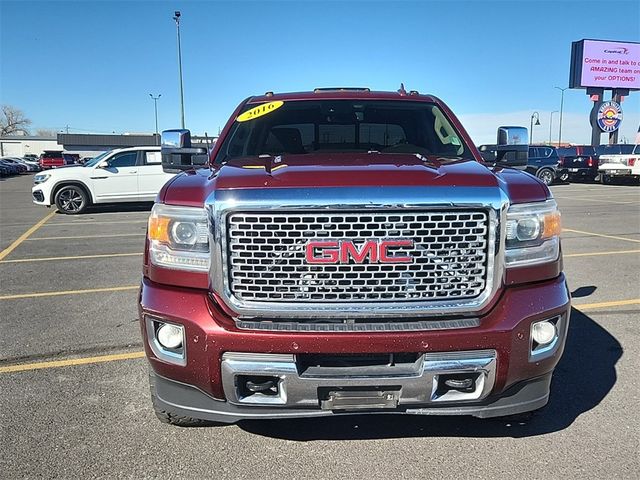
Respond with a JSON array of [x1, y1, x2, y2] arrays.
[[225, 210, 490, 304]]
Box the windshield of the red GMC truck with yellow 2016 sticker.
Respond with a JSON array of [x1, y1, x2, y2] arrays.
[[215, 100, 473, 163]]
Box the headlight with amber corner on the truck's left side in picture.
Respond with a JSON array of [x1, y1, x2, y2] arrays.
[[147, 204, 211, 272]]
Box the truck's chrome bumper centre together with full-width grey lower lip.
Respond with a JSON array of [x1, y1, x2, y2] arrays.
[[150, 350, 552, 423]]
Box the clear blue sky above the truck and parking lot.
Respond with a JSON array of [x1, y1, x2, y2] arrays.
[[0, 0, 640, 143]]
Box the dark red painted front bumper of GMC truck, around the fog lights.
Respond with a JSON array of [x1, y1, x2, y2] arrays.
[[140, 275, 570, 398]]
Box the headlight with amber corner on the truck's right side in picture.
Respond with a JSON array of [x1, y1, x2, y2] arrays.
[[505, 200, 561, 267]]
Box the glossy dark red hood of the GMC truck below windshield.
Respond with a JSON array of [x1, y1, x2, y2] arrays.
[[159, 153, 549, 206]]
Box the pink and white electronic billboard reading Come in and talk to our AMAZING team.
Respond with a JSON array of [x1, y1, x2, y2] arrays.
[[569, 40, 640, 90]]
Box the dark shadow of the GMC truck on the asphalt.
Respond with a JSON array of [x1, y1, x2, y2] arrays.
[[239, 309, 622, 442]]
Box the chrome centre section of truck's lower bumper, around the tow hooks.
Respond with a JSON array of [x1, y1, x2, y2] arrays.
[[222, 350, 496, 410]]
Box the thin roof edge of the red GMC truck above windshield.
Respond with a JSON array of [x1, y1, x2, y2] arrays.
[[247, 87, 441, 103]]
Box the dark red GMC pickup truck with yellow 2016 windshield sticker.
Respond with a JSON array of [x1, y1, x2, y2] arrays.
[[139, 89, 570, 426]]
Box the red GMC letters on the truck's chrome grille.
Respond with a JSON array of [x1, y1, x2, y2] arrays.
[[305, 240, 413, 264]]
